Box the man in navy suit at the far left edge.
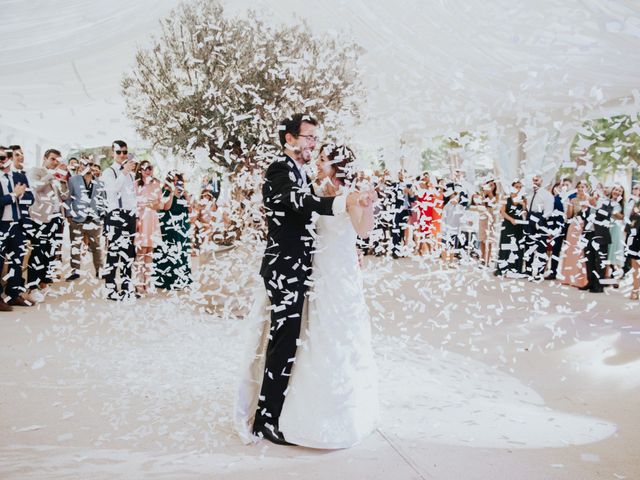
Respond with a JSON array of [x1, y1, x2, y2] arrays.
[[0, 146, 33, 312]]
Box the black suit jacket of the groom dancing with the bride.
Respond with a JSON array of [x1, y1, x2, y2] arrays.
[[260, 155, 333, 282]]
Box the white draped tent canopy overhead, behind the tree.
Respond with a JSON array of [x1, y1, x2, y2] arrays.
[[0, 0, 640, 175]]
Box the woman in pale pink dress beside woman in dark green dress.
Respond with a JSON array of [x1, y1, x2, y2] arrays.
[[136, 160, 162, 293]]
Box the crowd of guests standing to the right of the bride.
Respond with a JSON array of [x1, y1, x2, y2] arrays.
[[360, 171, 640, 299]]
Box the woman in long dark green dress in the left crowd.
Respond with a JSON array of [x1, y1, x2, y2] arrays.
[[153, 171, 193, 290]]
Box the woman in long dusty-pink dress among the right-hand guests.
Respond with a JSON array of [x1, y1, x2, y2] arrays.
[[561, 181, 589, 288]]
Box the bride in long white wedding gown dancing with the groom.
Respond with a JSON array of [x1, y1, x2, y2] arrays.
[[235, 145, 378, 449]]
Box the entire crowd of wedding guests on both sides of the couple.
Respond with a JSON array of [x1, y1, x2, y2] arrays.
[[0, 140, 640, 311]]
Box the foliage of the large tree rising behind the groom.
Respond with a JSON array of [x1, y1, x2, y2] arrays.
[[122, 0, 362, 171]]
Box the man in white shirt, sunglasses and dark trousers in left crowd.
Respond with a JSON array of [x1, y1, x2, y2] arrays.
[[100, 140, 137, 300]]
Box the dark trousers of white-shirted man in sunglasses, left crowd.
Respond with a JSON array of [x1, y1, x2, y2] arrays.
[[104, 209, 136, 291]]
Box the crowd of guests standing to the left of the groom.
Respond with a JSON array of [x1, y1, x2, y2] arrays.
[[0, 140, 229, 311]]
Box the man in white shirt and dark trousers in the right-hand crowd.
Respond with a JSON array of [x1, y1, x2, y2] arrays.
[[524, 175, 553, 280]]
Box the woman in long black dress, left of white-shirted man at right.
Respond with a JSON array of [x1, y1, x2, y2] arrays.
[[494, 180, 527, 276]]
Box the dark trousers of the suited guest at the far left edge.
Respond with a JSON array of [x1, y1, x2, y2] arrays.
[[0, 221, 26, 299]]
